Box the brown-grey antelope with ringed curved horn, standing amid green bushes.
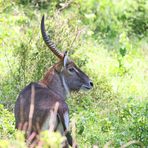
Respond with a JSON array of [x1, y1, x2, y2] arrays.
[[14, 15, 93, 147]]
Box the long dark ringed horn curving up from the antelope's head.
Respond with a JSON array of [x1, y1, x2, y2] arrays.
[[41, 15, 64, 59]]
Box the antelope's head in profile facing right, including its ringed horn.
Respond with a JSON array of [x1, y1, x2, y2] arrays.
[[41, 16, 93, 96]]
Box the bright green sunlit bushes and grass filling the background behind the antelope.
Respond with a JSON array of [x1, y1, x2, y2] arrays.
[[0, 0, 148, 147]]
